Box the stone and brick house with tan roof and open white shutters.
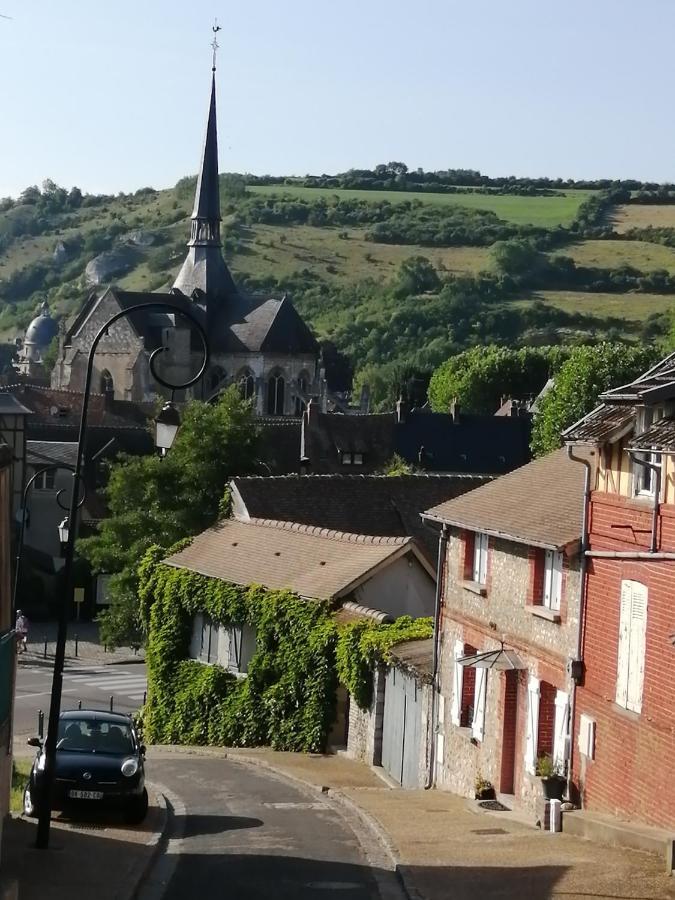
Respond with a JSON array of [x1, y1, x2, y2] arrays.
[[423, 450, 584, 810]]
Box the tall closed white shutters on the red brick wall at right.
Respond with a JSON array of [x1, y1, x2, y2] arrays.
[[616, 581, 647, 713]]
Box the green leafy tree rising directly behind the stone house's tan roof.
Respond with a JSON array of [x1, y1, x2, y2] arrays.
[[532, 343, 659, 456]]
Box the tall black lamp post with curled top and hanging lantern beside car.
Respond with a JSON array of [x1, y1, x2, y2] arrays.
[[35, 301, 209, 849]]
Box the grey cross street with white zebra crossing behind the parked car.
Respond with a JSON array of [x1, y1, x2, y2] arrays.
[[14, 662, 146, 736]]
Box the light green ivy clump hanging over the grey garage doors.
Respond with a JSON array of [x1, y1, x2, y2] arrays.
[[336, 616, 433, 709]]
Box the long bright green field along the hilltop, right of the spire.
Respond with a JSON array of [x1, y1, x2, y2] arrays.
[[247, 185, 593, 228]]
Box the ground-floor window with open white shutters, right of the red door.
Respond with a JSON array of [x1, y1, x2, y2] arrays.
[[525, 675, 569, 775]]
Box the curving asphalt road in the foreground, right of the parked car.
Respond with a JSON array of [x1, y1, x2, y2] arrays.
[[138, 750, 403, 900]]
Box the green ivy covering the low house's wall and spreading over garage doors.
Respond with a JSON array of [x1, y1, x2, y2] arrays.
[[139, 547, 431, 752]]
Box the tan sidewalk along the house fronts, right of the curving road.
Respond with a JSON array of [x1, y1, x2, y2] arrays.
[[207, 748, 675, 900]]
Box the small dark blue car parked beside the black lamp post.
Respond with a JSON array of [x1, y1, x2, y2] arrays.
[[23, 709, 148, 825]]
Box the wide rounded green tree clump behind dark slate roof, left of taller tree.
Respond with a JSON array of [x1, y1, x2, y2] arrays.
[[429, 345, 569, 415]]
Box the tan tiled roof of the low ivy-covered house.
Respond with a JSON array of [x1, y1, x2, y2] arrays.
[[165, 519, 414, 600]]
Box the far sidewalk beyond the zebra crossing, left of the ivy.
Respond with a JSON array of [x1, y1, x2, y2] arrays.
[[18, 622, 145, 665]]
